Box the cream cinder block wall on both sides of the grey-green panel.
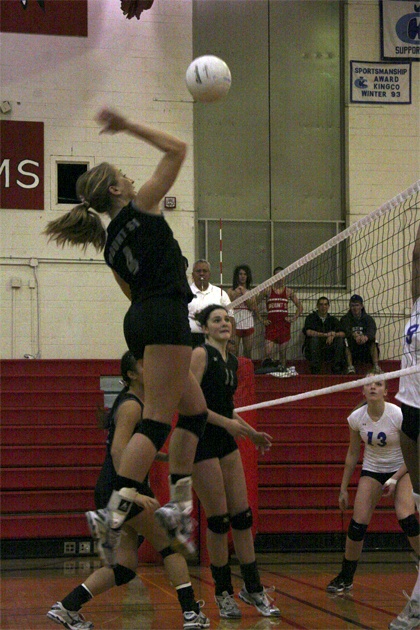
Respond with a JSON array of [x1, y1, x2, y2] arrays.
[[0, 0, 420, 358]]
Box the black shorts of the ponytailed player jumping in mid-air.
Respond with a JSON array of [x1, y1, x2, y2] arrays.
[[124, 295, 191, 359]]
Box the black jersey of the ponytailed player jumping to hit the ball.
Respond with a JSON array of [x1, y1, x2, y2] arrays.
[[104, 202, 193, 302]]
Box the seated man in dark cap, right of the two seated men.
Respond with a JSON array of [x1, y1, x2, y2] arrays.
[[340, 295, 380, 374]]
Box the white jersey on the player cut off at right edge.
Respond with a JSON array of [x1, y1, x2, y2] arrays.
[[395, 297, 420, 408]]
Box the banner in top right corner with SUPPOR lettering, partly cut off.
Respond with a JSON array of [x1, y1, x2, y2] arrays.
[[379, 0, 420, 61]]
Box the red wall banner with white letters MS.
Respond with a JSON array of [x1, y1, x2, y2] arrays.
[[0, 120, 44, 210]]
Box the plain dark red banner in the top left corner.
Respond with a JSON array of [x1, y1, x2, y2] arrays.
[[0, 0, 88, 37]]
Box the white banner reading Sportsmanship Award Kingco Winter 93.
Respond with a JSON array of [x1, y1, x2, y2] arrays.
[[350, 61, 411, 105]]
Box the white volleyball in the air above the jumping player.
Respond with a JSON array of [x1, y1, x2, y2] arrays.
[[185, 55, 232, 103]]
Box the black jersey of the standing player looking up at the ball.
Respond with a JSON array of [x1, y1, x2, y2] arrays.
[[201, 343, 238, 418]]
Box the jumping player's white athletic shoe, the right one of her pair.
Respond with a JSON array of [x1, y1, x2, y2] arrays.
[[155, 501, 196, 557]]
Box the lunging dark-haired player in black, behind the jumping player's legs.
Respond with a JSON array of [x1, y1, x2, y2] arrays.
[[47, 352, 209, 630]]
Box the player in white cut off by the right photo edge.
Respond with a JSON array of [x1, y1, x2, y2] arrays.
[[389, 226, 420, 630]]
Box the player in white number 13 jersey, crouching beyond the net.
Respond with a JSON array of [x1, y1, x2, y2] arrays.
[[327, 380, 420, 593]]
